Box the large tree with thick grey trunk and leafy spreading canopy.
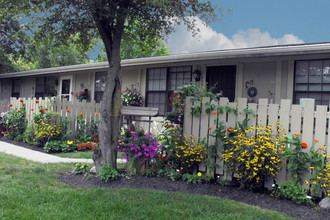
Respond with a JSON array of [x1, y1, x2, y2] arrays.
[[0, 0, 221, 167]]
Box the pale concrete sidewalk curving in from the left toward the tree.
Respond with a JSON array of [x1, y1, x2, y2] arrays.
[[0, 141, 94, 163]]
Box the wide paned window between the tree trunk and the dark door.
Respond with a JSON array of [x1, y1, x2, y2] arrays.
[[146, 66, 192, 115]]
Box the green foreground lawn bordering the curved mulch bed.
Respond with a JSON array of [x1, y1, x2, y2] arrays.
[[0, 153, 291, 219]]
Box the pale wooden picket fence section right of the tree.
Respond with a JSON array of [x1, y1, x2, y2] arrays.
[[184, 97, 330, 189]]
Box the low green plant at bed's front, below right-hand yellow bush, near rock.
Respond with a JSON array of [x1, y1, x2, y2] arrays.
[[272, 180, 314, 205]]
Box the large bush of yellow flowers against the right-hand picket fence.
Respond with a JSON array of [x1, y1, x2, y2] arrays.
[[222, 123, 286, 187]]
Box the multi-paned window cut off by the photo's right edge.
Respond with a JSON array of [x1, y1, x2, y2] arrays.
[[294, 60, 330, 106]]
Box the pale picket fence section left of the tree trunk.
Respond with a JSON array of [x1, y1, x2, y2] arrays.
[[6, 97, 101, 134]]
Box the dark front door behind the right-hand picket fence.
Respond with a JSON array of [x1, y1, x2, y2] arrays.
[[206, 66, 236, 102]]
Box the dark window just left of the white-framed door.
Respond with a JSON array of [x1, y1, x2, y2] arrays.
[[35, 76, 57, 98]]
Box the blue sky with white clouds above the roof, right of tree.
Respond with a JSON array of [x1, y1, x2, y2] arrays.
[[165, 0, 330, 54]]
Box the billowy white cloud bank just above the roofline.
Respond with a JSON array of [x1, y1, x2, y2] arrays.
[[166, 18, 304, 54]]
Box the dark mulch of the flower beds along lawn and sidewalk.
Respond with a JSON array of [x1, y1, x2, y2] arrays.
[[0, 138, 330, 219]]
